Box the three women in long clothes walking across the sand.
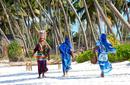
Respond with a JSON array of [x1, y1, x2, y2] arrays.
[[33, 32, 116, 78]]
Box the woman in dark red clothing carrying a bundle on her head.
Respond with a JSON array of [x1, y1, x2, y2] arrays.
[[33, 31, 50, 78]]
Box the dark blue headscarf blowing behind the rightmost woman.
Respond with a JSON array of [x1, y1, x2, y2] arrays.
[[100, 33, 115, 52]]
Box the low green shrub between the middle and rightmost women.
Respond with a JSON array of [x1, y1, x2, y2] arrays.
[[76, 50, 93, 63]]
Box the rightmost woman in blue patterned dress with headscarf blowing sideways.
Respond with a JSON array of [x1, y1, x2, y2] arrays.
[[94, 34, 116, 77]]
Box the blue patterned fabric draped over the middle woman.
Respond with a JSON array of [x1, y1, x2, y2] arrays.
[[59, 37, 72, 72]]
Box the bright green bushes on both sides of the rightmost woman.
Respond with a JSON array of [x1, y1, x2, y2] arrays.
[[76, 44, 130, 63]]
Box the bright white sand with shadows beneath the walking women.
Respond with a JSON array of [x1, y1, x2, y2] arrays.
[[0, 61, 130, 85]]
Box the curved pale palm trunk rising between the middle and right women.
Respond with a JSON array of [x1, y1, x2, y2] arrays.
[[67, 0, 88, 49]]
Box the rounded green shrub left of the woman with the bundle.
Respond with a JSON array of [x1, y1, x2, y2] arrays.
[[8, 41, 23, 61]]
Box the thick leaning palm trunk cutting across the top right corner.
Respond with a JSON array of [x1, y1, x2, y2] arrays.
[[107, 0, 130, 31]]
